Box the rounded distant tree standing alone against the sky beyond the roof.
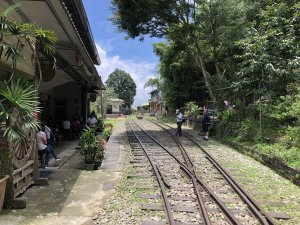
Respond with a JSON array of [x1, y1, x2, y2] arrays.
[[105, 69, 136, 109]]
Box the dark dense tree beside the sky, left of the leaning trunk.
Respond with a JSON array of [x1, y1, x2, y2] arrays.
[[154, 41, 208, 108]]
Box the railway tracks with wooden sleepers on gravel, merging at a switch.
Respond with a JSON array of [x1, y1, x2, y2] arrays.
[[127, 118, 290, 225]]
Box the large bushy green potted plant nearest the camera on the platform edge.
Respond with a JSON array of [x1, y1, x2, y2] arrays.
[[76, 129, 102, 170]]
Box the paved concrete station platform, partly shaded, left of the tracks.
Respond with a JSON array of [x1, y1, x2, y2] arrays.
[[0, 121, 127, 225]]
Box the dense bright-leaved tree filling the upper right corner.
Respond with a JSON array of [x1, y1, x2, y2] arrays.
[[234, 3, 300, 100]]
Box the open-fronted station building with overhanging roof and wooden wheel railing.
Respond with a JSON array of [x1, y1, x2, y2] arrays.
[[0, 0, 105, 207]]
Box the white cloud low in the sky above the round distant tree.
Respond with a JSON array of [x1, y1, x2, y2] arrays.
[[96, 44, 156, 106]]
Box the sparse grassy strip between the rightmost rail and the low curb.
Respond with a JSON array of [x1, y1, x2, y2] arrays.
[[212, 145, 300, 225]]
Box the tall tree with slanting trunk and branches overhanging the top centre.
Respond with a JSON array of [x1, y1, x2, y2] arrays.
[[112, 0, 250, 101]]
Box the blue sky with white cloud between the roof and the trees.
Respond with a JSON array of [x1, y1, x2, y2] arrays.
[[83, 0, 161, 106]]
